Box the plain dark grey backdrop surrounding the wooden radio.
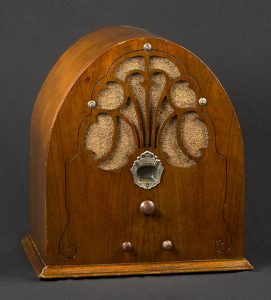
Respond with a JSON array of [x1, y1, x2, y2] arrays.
[[0, 0, 271, 300]]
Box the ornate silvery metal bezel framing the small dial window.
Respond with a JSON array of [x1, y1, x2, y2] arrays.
[[131, 151, 164, 190]]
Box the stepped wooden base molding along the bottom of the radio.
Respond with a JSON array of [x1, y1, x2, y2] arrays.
[[22, 234, 253, 279]]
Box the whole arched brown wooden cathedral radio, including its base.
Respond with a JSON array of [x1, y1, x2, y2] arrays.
[[22, 26, 252, 278]]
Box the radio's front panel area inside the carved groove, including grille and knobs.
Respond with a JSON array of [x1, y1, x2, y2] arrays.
[[59, 45, 234, 264]]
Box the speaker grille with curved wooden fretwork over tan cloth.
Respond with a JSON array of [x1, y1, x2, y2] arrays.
[[85, 51, 208, 170]]
